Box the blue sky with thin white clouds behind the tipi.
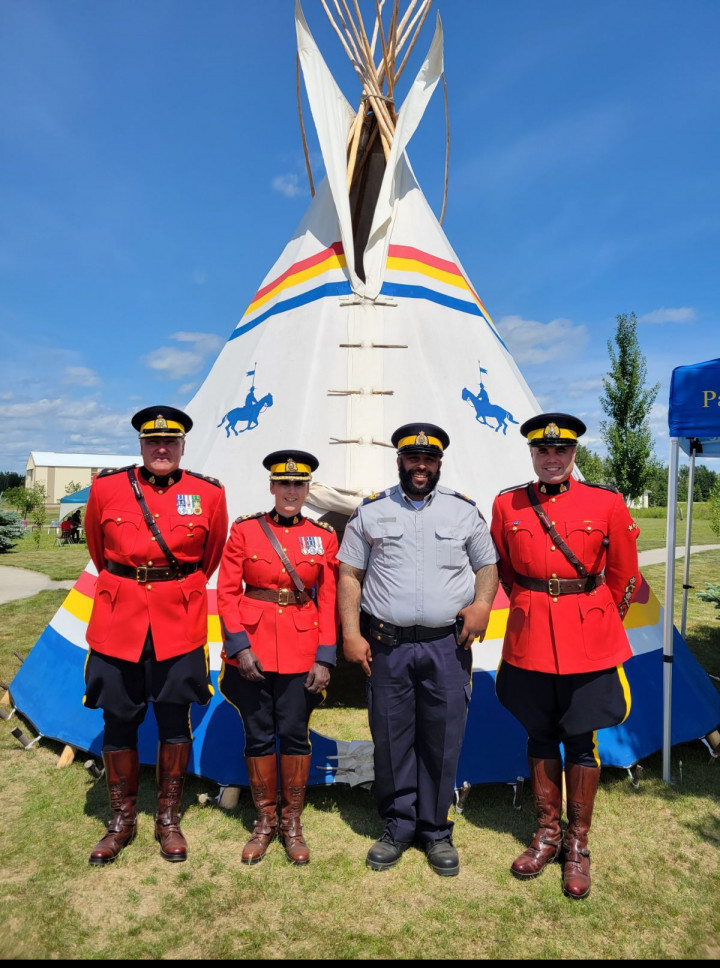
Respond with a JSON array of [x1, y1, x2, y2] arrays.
[[0, 0, 720, 472]]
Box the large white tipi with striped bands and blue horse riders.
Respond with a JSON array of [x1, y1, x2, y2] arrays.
[[11, 0, 720, 787]]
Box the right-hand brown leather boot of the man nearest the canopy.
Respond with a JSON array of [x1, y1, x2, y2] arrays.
[[563, 763, 600, 899]]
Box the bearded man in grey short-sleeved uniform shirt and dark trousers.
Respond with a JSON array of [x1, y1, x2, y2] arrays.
[[338, 423, 498, 877]]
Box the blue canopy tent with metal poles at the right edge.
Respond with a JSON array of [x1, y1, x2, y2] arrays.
[[663, 359, 720, 783]]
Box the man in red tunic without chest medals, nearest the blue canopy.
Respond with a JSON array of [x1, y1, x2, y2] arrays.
[[491, 413, 640, 898]]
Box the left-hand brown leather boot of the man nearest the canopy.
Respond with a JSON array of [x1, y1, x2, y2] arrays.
[[510, 758, 562, 880]]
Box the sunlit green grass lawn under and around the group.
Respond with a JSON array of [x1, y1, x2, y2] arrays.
[[0, 522, 720, 961]]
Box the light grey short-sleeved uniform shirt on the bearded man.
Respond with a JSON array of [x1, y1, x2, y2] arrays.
[[338, 484, 498, 628]]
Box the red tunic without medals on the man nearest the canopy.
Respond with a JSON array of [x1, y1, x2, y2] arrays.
[[490, 479, 640, 675]]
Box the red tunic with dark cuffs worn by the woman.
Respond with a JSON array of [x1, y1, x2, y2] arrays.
[[217, 513, 338, 673]]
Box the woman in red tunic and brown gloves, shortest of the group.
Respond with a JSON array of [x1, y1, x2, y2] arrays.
[[217, 450, 338, 864]]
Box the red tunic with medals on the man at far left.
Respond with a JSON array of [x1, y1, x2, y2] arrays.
[[85, 467, 228, 662]]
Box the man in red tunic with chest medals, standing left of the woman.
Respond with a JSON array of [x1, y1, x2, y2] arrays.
[[84, 406, 228, 865]]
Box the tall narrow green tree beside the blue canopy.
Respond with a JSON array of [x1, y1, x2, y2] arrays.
[[600, 313, 660, 501]]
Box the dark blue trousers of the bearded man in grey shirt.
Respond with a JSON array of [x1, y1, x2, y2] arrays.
[[368, 635, 472, 844]]
